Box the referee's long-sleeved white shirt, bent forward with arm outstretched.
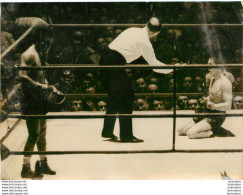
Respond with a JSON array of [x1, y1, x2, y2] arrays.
[[109, 27, 173, 74]]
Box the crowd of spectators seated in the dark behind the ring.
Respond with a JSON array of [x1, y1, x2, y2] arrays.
[[1, 2, 243, 114]]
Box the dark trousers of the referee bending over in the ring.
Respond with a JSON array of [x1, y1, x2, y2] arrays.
[[100, 49, 135, 140]]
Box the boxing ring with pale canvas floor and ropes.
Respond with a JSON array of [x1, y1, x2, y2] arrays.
[[1, 20, 243, 179]]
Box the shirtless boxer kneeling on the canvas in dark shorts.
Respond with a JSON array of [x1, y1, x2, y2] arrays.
[[178, 58, 234, 139]]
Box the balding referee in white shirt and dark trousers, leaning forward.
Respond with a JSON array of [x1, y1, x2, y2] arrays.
[[100, 17, 172, 143]]
